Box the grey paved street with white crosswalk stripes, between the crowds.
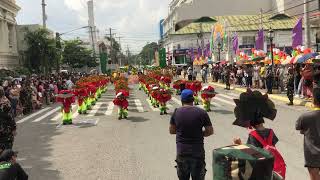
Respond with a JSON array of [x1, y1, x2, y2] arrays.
[[15, 83, 308, 180]]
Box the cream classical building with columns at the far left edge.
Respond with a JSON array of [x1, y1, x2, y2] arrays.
[[0, 0, 20, 69]]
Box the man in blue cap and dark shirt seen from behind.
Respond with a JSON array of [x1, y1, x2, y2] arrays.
[[169, 89, 213, 180]]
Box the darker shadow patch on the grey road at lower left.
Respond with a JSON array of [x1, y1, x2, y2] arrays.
[[14, 122, 62, 180]]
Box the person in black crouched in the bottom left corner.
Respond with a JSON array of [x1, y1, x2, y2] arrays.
[[0, 149, 28, 180]]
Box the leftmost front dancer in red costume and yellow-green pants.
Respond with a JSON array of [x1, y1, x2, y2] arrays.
[[57, 90, 75, 125]]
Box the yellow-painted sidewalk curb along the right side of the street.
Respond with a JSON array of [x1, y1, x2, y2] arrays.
[[209, 82, 313, 108]]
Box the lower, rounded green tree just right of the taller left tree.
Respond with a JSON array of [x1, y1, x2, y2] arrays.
[[62, 39, 97, 68]]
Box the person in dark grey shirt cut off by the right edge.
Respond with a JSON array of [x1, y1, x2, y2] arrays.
[[296, 88, 320, 180]]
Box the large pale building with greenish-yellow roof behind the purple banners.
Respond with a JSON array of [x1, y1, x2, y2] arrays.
[[160, 0, 320, 64]]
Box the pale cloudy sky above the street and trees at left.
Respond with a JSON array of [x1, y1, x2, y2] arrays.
[[17, 0, 171, 52]]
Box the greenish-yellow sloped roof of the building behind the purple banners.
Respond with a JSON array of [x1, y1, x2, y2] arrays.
[[171, 14, 319, 35]]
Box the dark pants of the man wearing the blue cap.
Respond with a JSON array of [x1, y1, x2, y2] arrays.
[[176, 155, 207, 180]]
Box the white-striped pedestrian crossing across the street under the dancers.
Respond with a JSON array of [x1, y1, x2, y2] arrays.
[[17, 93, 296, 124]]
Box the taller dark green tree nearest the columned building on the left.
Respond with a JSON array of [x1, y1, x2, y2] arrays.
[[25, 29, 57, 74]]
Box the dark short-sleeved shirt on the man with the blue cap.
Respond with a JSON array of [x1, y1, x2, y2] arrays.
[[170, 106, 212, 157]]
